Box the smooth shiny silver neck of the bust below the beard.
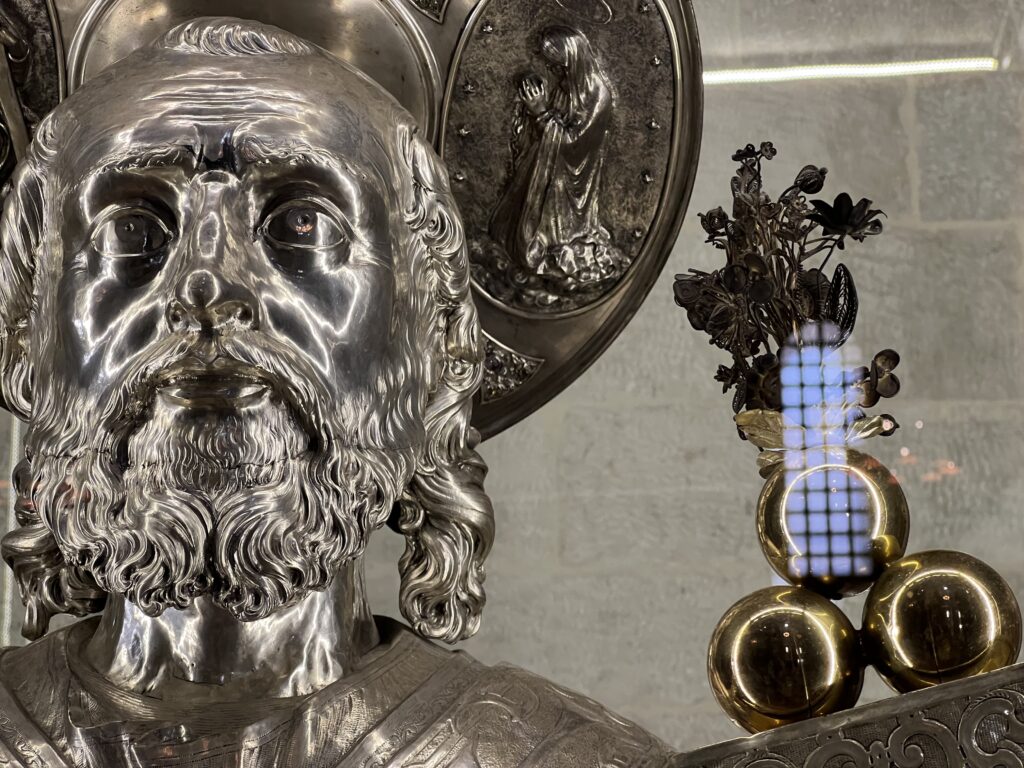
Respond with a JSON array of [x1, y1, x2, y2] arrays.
[[78, 560, 379, 702]]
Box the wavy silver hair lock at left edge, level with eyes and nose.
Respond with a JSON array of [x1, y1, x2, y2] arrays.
[[0, 154, 43, 419]]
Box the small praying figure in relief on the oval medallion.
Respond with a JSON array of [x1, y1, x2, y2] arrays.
[[483, 27, 629, 310]]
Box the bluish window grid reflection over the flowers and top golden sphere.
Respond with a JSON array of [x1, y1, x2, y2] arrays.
[[780, 326, 872, 578]]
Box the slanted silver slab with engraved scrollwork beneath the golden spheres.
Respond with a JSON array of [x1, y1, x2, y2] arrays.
[[675, 665, 1024, 768]]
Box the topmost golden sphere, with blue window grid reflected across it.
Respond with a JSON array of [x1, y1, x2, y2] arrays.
[[758, 447, 910, 599]]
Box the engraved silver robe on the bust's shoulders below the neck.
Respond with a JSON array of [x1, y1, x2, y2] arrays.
[[0, 618, 671, 768]]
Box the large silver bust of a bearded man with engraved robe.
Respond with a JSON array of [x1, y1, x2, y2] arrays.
[[0, 18, 673, 768]]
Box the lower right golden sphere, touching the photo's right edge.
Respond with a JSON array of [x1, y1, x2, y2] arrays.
[[862, 551, 1021, 693]]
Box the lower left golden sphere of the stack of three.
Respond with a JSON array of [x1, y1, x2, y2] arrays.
[[708, 587, 864, 733]]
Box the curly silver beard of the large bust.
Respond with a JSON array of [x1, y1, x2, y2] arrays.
[[24, 333, 414, 621]]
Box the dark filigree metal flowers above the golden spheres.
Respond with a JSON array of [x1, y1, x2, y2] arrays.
[[674, 141, 899, 437]]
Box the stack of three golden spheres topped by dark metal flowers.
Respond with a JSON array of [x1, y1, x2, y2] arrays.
[[675, 141, 1021, 731]]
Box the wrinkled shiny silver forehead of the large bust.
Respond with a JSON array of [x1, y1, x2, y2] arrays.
[[52, 54, 394, 180]]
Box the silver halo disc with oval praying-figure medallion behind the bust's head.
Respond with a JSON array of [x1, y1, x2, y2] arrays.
[[36, 0, 702, 438]]
